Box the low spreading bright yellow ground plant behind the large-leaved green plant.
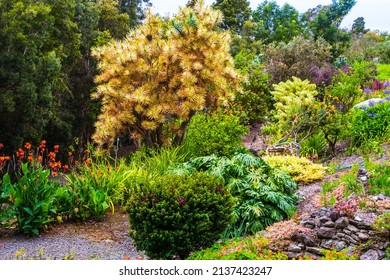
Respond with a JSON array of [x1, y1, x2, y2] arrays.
[[263, 156, 326, 184]]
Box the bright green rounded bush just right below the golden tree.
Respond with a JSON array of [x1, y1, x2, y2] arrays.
[[184, 113, 248, 157]]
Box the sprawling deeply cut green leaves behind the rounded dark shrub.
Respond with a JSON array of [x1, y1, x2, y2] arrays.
[[169, 153, 298, 237]]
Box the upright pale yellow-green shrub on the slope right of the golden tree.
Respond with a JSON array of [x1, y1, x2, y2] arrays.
[[271, 77, 317, 122]]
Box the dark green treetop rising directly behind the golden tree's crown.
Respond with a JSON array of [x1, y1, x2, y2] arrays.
[[213, 0, 251, 34]]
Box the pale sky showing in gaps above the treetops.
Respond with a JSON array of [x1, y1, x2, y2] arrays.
[[151, 0, 390, 32]]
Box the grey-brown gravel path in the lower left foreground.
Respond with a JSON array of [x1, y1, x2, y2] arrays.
[[0, 208, 144, 260]]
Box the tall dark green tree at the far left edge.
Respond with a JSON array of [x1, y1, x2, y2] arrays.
[[0, 0, 62, 150]]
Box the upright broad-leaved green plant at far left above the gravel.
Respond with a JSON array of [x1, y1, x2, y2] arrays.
[[1, 163, 59, 235]]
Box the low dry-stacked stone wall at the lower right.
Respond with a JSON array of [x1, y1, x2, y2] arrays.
[[284, 208, 390, 260]]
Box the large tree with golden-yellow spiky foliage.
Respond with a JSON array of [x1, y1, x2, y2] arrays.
[[93, 1, 239, 149]]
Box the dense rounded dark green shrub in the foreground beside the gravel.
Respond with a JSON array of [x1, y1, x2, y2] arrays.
[[126, 173, 233, 259]]
